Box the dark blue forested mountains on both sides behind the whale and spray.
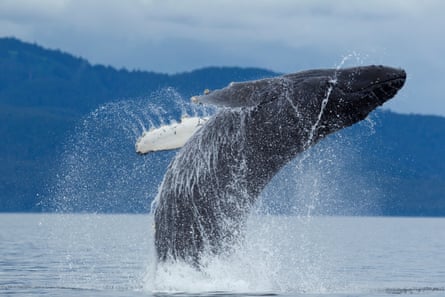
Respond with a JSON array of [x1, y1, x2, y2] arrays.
[[0, 38, 445, 215]]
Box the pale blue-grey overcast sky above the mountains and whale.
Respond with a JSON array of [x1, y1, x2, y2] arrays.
[[0, 0, 445, 116]]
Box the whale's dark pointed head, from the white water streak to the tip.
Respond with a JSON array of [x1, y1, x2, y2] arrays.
[[308, 66, 406, 137]]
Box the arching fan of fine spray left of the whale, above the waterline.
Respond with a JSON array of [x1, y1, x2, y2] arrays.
[[45, 88, 209, 212]]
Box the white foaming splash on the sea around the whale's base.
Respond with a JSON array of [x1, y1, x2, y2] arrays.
[[144, 214, 341, 295]]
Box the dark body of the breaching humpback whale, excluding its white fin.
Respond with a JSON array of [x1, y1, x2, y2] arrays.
[[154, 65, 406, 268]]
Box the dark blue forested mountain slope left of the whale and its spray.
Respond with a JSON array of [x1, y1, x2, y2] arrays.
[[0, 38, 273, 211]]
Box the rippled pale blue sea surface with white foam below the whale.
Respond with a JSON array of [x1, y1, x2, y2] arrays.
[[0, 214, 445, 296]]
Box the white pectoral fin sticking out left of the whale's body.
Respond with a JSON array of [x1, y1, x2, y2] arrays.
[[135, 117, 209, 154]]
